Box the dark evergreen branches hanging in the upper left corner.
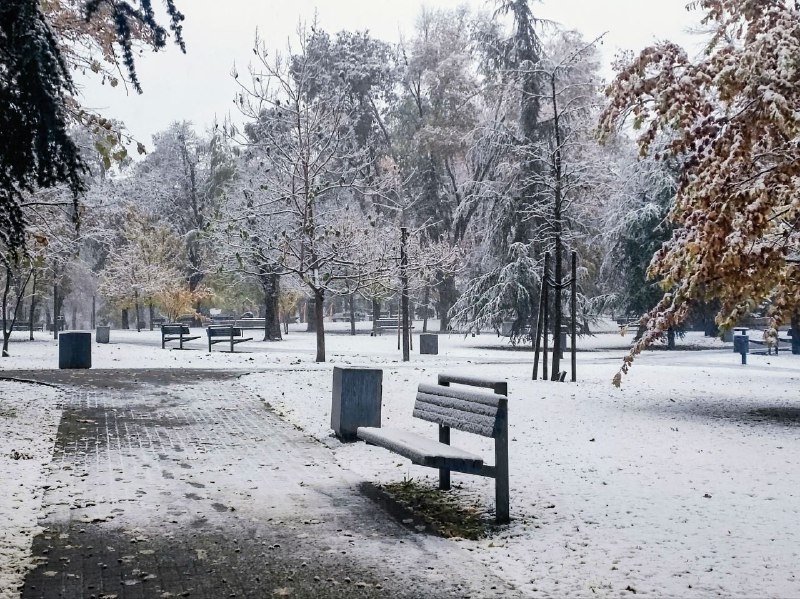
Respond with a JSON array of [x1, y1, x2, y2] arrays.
[[0, 0, 183, 254]]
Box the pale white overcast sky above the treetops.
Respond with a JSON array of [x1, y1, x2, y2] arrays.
[[78, 0, 696, 147]]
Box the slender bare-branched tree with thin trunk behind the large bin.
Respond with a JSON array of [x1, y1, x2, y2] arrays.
[[234, 30, 382, 362]]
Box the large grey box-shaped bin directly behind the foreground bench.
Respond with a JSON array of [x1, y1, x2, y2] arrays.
[[331, 366, 383, 440]]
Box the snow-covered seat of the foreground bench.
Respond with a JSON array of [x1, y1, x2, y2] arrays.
[[356, 426, 483, 471]]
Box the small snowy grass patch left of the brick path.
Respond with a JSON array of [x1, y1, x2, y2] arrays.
[[0, 381, 61, 599]]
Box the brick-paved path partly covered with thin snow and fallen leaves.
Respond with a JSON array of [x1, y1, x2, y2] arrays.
[[8, 371, 514, 599]]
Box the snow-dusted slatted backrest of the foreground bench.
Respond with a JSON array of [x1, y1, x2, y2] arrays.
[[414, 383, 508, 437]]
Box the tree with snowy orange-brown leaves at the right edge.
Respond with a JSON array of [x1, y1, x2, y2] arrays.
[[601, 0, 800, 385]]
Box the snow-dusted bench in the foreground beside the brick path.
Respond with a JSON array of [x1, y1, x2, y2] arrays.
[[356, 374, 509, 524]]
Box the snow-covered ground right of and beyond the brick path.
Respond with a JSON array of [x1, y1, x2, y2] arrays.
[[0, 323, 800, 597]]
